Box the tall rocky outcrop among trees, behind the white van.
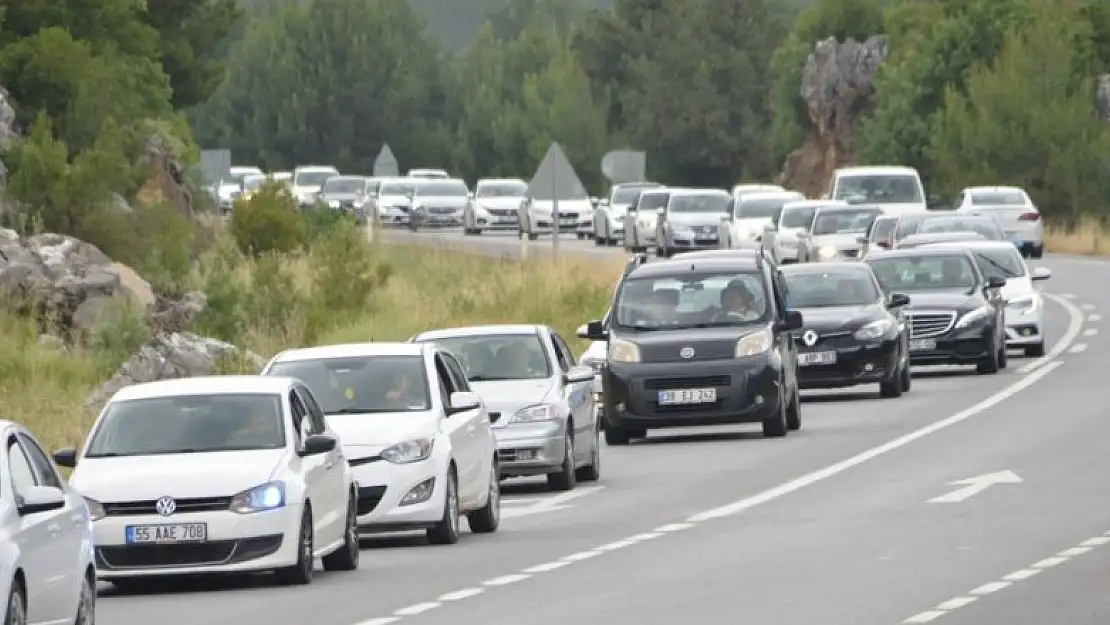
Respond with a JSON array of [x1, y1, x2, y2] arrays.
[[780, 34, 887, 198]]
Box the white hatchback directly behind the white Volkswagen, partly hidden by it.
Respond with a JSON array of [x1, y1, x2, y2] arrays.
[[263, 343, 501, 545]]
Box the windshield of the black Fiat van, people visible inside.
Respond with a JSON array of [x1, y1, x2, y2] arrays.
[[615, 272, 767, 330]]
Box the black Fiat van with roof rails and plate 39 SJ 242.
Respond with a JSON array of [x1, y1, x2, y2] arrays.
[[585, 251, 803, 445]]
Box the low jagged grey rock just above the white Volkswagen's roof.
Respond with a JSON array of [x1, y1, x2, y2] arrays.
[[87, 332, 265, 411]]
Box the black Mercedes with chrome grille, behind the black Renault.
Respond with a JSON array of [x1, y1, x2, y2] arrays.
[[864, 248, 1006, 373]]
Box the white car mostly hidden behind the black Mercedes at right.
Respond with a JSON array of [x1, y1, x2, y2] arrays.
[[924, 241, 1052, 357]]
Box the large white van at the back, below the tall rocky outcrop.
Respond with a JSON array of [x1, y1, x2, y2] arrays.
[[823, 165, 929, 216]]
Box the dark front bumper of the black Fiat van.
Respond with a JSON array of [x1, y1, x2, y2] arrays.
[[602, 355, 781, 431]]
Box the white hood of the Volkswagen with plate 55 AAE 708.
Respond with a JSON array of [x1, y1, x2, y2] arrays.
[[70, 448, 290, 502]]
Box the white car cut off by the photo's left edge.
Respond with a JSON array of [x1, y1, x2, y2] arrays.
[[0, 421, 97, 625]]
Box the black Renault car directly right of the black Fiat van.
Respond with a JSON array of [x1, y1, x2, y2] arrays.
[[780, 262, 910, 397]]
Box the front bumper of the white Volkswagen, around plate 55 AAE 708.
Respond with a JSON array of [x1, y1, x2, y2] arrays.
[[93, 504, 302, 581]]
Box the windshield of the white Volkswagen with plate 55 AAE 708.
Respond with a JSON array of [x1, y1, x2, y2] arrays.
[[85, 394, 285, 457]]
